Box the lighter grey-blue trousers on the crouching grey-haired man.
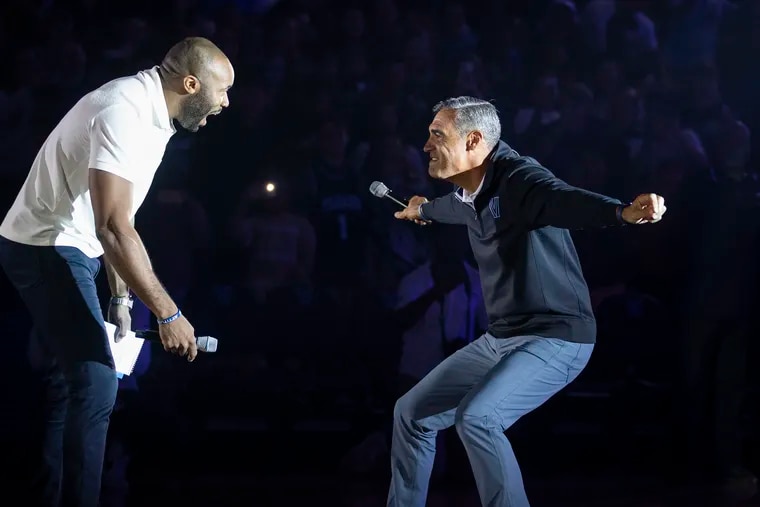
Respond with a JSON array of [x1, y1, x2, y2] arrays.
[[388, 334, 594, 507]]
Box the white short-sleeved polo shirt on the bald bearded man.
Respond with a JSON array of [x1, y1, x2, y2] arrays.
[[0, 67, 176, 258]]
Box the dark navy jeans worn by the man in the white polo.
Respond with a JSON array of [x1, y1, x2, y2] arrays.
[[0, 237, 118, 507]]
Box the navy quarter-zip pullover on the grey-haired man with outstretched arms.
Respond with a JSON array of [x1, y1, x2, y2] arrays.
[[420, 141, 623, 343]]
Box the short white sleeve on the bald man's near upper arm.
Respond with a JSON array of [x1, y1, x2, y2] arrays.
[[89, 106, 144, 183]]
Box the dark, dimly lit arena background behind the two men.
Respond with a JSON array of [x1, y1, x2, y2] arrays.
[[0, 0, 760, 506]]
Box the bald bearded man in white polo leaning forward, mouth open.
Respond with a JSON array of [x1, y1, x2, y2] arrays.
[[0, 38, 234, 507]]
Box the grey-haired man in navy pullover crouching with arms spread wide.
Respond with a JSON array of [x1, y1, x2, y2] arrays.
[[388, 97, 665, 507]]
